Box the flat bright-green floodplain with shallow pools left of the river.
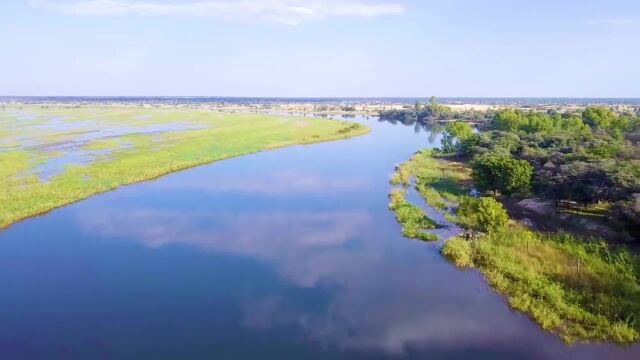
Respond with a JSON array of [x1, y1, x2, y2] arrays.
[[0, 105, 369, 228]]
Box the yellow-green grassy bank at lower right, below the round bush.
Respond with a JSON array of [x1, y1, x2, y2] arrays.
[[443, 228, 640, 343]]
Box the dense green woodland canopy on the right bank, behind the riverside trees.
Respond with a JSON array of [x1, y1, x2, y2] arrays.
[[476, 107, 640, 225]]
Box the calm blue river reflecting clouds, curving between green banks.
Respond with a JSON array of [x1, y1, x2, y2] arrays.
[[0, 119, 640, 359]]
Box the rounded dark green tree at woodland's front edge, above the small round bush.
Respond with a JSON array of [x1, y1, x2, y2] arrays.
[[471, 153, 533, 196]]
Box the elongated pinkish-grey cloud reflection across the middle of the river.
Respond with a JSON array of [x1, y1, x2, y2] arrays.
[[79, 209, 371, 286]]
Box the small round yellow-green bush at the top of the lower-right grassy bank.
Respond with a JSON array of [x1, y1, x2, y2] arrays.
[[456, 197, 509, 233]]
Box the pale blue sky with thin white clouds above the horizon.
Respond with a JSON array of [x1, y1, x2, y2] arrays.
[[0, 0, 640, 97]]
